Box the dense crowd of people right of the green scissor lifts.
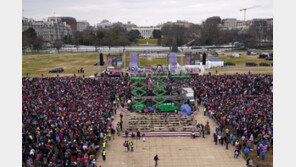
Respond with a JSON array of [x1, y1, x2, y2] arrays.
[[191, 74, 273, 160]]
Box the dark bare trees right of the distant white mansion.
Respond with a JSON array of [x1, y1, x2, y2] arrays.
[[161, 21, 273, 48]]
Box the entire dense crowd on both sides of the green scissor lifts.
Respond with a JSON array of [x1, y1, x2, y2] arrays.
[[22, 74, 273, 166]]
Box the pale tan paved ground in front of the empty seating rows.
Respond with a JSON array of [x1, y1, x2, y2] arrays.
[[97, 107, 246, 167]]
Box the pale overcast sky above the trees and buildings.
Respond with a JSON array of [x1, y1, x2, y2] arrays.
[[23, 0, 273, 26]]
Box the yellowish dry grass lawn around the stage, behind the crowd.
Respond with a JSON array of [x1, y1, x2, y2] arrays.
[[22, 52, 273, 77]]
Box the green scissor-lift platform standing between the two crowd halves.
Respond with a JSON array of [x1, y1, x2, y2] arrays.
[[130, 75, 195, 111]]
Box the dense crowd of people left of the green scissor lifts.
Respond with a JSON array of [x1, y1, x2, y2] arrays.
[[22, 77, 130, 166]]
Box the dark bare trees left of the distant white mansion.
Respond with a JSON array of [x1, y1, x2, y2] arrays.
[[22, 25, 141, 51]]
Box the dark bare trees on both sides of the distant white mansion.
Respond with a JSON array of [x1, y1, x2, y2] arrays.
[[23, 21, 273, 50]]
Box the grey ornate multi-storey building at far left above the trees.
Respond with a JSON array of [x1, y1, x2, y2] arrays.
[[22, 18, 72, 42]]
